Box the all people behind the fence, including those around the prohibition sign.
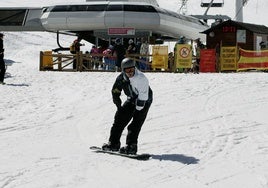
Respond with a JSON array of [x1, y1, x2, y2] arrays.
[[72, 36, 204, 73]]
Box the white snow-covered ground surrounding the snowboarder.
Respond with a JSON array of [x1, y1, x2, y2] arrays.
[[0, 0, 268, 188]]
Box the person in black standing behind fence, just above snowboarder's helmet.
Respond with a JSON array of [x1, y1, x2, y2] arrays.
[[113, 38, 126, 71]]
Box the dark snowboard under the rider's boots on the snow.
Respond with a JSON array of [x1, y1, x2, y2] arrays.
[[90, 146, 151, 161]]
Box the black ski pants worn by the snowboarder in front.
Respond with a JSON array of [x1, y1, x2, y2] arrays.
[[109, 100, 151, 145]]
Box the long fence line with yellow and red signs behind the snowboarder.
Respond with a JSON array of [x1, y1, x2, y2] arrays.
[[40, 45, 268, 72]]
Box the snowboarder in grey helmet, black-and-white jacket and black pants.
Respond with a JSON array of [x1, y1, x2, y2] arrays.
[[102, 58, 153, 154]]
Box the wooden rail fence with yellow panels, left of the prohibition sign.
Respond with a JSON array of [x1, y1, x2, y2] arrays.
[[39, 51, 168, 71]]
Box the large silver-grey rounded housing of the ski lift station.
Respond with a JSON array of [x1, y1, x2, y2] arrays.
[[0, 0, 209, 45]]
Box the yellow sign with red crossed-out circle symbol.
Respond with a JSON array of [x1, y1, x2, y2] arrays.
[[175, 44, 192, 68]]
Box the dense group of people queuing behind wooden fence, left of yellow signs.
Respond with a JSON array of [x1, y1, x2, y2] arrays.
[[70, 38, 150, 71]]
